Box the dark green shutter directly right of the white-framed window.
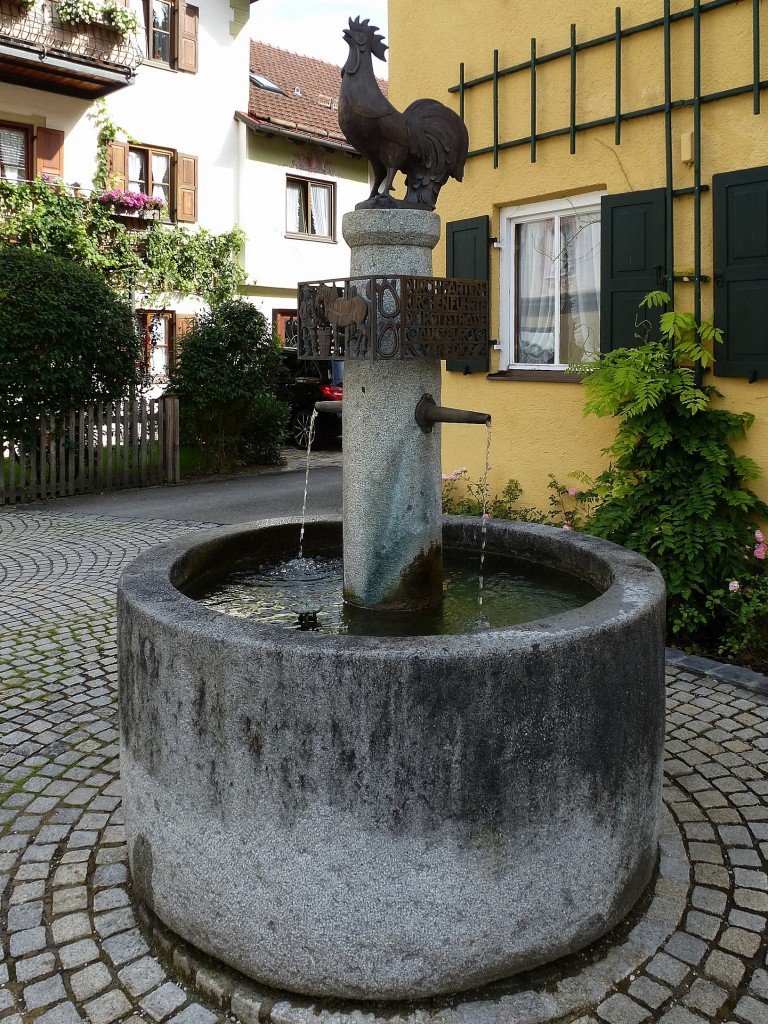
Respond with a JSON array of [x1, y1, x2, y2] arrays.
[[600, 188, 667, 352]]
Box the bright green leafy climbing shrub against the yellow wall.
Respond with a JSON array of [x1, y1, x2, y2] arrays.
[[579, 292, 768, 643]]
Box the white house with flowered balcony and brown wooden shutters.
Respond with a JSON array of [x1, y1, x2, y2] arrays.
[[0, 0, 250, 377]]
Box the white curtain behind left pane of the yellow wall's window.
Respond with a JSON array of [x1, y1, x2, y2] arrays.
[[515, 218, 557, 364]]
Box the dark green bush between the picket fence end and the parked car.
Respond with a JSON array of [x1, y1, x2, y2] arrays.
[[168, 299, 287, 472]]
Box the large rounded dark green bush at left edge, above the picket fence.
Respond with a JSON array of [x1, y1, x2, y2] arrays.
[[0, 244, 138, 437]]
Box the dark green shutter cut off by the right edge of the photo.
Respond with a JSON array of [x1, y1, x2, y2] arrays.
[[712, 167, 768, 381]]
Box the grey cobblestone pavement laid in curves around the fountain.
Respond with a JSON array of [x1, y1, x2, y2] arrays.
[[0, 511, 768, 1024]]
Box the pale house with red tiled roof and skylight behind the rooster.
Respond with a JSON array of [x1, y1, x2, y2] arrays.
[[237, 40, 376, 342]]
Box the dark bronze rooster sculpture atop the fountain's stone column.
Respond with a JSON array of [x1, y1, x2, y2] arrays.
[[339, 17, 469, 210]]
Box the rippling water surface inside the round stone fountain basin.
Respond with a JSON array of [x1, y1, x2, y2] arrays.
[[184, 551, 598, 636]]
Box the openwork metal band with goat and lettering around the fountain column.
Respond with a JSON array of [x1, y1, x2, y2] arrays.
[[298, 275, 488, 359]]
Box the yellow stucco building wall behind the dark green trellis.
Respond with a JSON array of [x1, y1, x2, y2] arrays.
[[388, 0, 768, 507]]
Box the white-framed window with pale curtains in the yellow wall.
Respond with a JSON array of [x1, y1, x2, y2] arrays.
[[501, 196, 600, 370]]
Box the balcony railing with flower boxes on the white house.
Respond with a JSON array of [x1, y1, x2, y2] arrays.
[[0, 0, 143, 84]]
